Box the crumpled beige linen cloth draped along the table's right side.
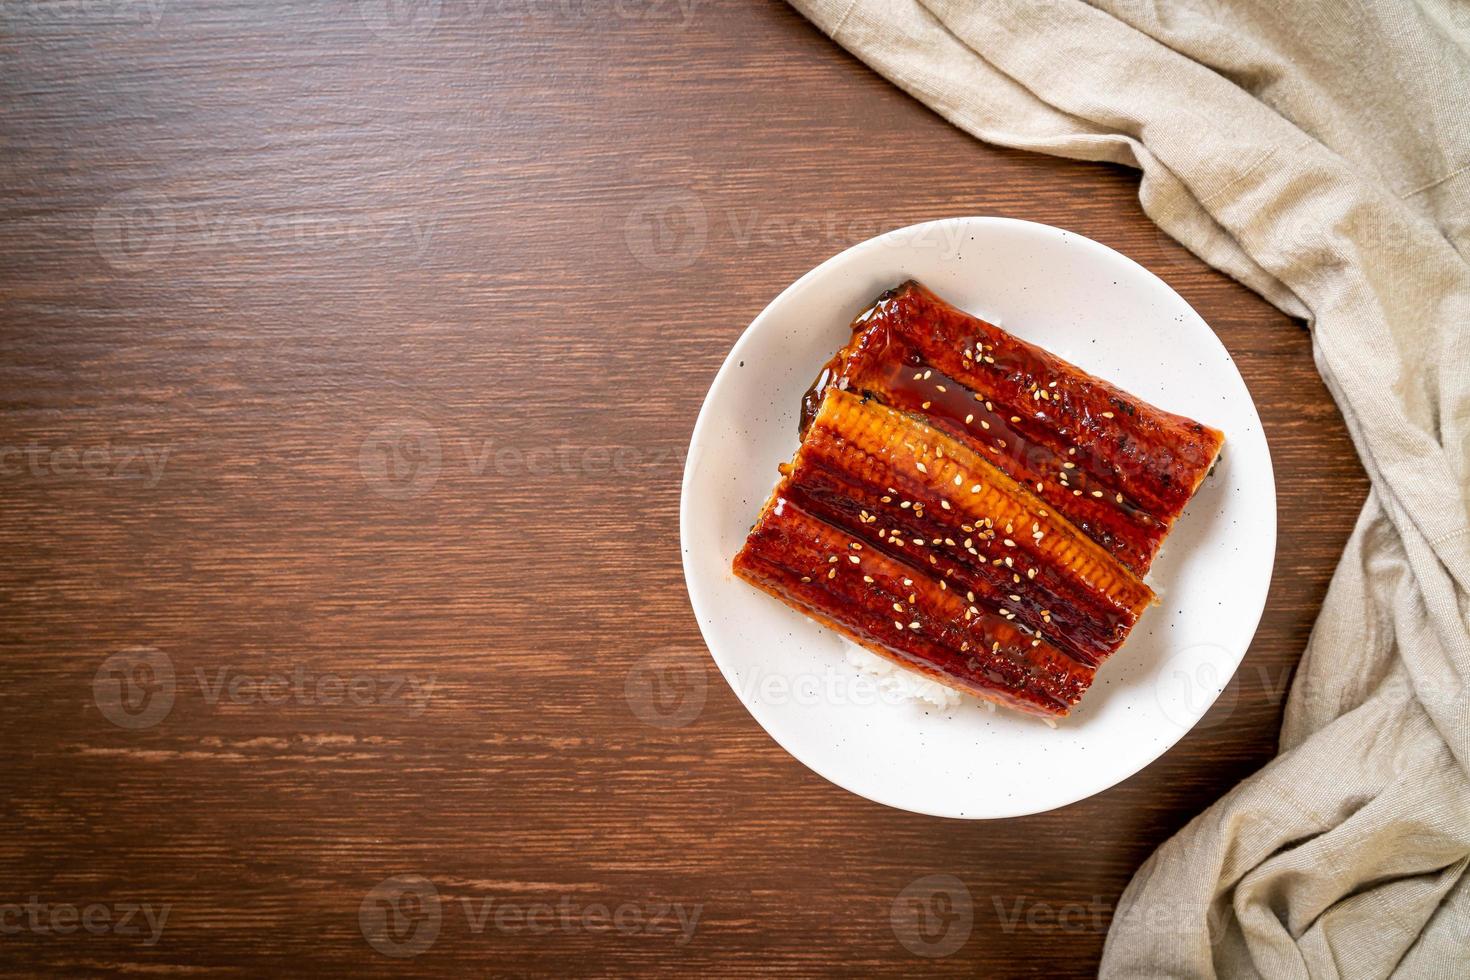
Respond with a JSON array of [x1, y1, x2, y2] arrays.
[[792, 0, 1470, 980]]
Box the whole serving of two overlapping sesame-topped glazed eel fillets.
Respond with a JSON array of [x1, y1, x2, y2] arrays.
[[735, 281, 1225, 717]]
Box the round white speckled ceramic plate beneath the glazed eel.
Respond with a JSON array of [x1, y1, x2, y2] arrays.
[[679, 217, 1276, 818]]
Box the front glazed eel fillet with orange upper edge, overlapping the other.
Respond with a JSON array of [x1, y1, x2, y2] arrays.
[[735, 389, 1152, 716]]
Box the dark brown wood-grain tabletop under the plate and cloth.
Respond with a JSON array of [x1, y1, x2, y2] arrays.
[[0, 0, 1366, 977]]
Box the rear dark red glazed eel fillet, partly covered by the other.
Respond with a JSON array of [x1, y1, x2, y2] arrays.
[[803, 279, 1225, 574]]
